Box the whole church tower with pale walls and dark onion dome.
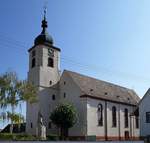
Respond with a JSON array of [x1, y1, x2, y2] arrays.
[[26, 11, 60, 135]]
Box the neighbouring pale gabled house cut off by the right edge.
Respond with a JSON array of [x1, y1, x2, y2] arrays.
[[139, 89, 150, 138]]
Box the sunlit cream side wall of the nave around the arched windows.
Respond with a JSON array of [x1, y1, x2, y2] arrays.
[[87, 98, 139, 139]]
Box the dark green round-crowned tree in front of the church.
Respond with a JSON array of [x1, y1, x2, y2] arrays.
[[50, 103, 77, 137]]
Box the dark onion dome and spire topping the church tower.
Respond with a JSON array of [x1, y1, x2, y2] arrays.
[[34, 9, 53, 45]]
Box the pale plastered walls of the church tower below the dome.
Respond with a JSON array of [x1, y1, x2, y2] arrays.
[[26, 45, 60, 135]]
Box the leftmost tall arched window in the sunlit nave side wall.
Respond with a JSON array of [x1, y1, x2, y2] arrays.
[[97, 104, 103, 126]]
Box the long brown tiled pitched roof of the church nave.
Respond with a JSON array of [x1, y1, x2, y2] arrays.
[[64, 70, 140, 105]]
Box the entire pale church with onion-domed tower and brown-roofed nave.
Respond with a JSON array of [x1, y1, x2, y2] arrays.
[[26, 12, 140, 140]]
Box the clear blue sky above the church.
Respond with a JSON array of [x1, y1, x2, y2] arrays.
[[0, 0, 150, 127]]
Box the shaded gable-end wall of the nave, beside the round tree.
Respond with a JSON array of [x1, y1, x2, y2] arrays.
[[59, 73, 87, 136]]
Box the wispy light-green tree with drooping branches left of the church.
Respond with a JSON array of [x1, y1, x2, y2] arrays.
[[0, 72, 37, 133]]
